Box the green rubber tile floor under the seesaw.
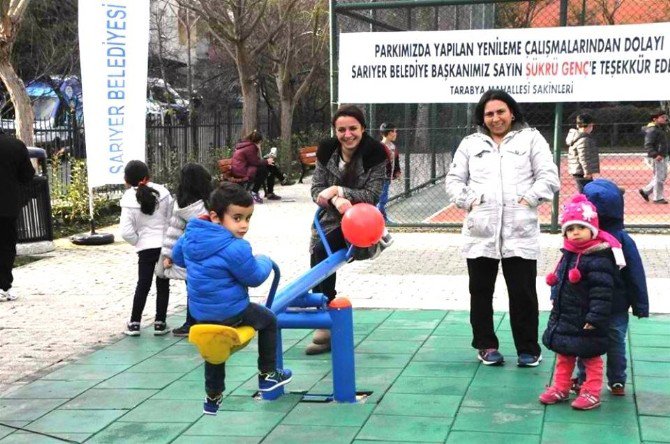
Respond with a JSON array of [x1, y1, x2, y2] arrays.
[[0, 309, 670, 444]]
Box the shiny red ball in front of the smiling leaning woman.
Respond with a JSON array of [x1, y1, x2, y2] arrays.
[[342, 203, 384, 248]]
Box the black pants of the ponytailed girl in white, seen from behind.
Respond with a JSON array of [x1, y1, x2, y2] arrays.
[[130, 248, 170, 322]]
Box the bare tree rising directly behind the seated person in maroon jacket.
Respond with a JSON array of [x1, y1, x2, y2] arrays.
[[178, 0, 298, 133]]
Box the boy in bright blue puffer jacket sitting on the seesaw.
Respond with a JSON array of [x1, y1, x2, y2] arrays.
[[172, 183, 292, 415]]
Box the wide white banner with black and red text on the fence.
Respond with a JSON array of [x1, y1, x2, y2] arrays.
[[338, 23, 670, 103]]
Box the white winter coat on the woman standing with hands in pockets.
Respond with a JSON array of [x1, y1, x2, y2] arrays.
[[446, 124, 560, 260]]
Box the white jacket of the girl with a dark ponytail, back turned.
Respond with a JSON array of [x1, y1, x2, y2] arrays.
[[121, 182, 172, 251]]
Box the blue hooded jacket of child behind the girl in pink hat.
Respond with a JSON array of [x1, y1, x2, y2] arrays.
[[584, 179, 649, 318]]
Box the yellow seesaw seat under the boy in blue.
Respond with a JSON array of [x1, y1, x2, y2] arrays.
[[188, 324, 256, 364]]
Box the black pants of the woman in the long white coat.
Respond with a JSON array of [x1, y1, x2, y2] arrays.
[[468, 257, 540, 356]]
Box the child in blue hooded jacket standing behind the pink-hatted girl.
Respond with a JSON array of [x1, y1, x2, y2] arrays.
[[575, 179, 649, 396]]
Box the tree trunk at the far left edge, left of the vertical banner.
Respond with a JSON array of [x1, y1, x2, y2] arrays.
[[0, 47, 35, 146]]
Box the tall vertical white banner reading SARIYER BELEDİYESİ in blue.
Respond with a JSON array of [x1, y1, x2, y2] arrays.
[[79, 0, 149, 188]]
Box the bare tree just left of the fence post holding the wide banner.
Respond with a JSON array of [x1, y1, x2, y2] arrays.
[[268, 0, 328, 154]]
